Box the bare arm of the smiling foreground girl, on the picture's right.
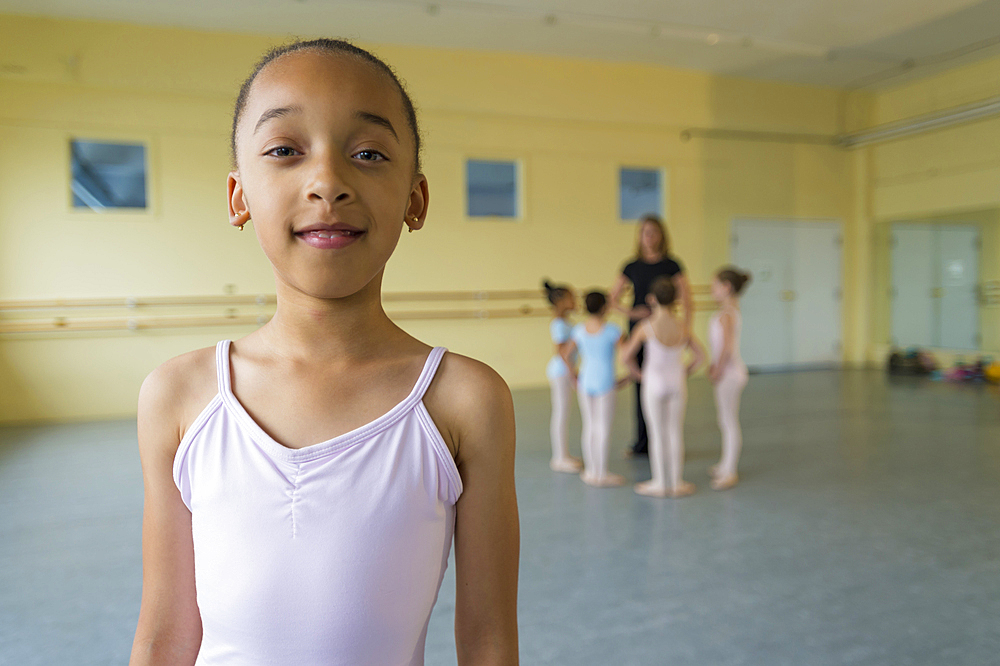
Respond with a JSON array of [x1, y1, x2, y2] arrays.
[[429, 354, 520, 666]]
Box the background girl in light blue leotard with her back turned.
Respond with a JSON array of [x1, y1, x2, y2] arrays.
[[560, 291, 628, 486]]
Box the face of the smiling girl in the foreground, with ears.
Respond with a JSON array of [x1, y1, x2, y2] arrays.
[[229, 51, 428, 299]]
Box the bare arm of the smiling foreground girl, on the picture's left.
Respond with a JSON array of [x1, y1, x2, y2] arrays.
[[129, 362, 201, 666]]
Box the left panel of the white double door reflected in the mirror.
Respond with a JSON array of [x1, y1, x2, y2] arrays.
[[891, 223, 937, 347]]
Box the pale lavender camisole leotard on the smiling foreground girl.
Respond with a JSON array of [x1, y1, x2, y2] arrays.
[[174, 340, 462, 666]]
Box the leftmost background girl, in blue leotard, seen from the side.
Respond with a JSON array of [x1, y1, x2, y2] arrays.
[[544, 281, 582, 474]]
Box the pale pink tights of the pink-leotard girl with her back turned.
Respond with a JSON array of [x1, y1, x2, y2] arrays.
[[641, 382, 687, 490]]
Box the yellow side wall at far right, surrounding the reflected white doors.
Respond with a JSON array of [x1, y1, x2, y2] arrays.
[[859, 58, 1000, 359]]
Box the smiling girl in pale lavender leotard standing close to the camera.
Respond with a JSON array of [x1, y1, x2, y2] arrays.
[[131, 40, 518, 666]]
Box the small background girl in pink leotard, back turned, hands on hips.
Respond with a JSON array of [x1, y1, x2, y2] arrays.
[[622, 277, 705, 497]]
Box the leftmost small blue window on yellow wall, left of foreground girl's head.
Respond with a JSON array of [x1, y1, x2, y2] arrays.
[[72, 141, 146, 210]]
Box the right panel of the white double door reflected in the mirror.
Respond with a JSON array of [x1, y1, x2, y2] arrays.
[[935, 225, 979, 349]]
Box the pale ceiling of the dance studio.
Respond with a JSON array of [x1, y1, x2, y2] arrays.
[[0, 0, 1000, 88]]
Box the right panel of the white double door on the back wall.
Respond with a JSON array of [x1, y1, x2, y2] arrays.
[[792, 223, 842, 365]]
